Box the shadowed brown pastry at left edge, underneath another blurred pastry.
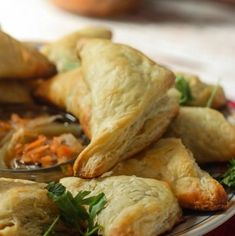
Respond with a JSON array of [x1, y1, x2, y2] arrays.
[[0, 80, 32, 103]]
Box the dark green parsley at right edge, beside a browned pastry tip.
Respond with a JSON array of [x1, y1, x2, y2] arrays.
[[218, 159, 235, 188]]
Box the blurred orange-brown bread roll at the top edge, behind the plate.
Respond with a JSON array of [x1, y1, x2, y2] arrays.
[[52, 0, 140, 17]]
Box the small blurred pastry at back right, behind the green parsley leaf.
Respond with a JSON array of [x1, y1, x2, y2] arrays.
[[176, 73, 227, 109]]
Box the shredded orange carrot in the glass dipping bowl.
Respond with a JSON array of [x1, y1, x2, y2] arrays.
[[0, 114, 83, 167]]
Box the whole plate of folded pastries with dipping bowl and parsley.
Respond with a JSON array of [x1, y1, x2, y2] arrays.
[[0, 27, 235, 236]]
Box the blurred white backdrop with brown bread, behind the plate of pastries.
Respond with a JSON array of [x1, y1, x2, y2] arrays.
[[0, 0, 235, 100]]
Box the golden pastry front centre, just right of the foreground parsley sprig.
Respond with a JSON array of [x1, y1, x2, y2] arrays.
[[60, 176, 181, 236]]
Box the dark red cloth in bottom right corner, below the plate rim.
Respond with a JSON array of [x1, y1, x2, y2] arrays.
[[205, 216, 235, 236]]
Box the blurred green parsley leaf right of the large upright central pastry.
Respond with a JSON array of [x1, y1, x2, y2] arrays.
[[175, 76, 193, 105]]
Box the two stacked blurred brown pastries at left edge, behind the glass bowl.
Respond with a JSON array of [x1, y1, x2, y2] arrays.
[[0, 31, 56, 103]]
